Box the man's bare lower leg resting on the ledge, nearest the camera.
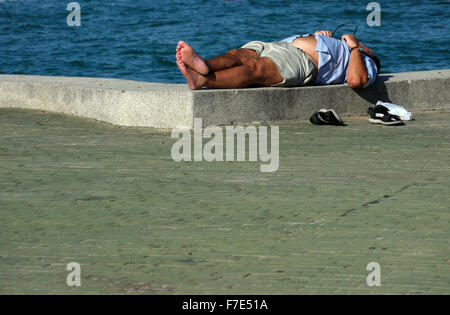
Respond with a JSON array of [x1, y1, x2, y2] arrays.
[[177, 58, 284, 90]]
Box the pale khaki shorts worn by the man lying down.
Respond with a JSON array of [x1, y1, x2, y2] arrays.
[[241, 41, 317, 87]]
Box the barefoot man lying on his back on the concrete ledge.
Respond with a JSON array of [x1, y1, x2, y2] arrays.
[[176, 31, 380, 90]]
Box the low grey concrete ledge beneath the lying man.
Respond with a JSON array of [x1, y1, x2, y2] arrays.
[[0, 69, 450, 128]]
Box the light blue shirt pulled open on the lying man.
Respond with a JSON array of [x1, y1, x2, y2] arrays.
[[282, 34, 377, 88]]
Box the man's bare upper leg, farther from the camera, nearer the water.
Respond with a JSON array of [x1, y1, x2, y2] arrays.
[[177, 41, 259, 75]]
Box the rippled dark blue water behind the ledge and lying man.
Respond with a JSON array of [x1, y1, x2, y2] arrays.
[[0, 0, 450, 83]]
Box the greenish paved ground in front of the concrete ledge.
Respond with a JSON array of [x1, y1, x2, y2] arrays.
[[0, 109, 450, 294]]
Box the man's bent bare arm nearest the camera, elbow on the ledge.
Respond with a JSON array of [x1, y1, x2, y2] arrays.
[[342, 34, 368, 89]]
